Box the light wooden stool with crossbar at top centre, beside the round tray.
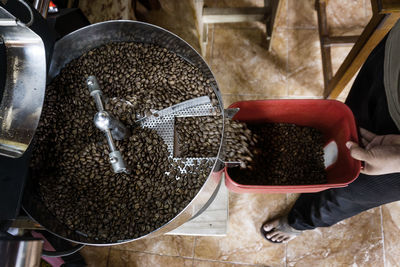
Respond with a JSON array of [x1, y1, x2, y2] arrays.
[[196, 0, 282, 55]]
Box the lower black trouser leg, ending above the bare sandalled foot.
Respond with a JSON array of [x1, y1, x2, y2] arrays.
[[288, 173, 400, 230]]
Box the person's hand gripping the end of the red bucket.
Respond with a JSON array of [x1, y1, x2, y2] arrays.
[[346, 128, 400, 175]]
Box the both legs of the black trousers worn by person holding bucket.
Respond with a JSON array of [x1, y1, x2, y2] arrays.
[[288, 34, 400, 230]]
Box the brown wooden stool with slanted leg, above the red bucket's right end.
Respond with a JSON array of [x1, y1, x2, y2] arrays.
[[315, 0, 400, 99]]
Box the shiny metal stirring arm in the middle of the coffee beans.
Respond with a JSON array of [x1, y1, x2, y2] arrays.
[[86, 76, 129, 173]]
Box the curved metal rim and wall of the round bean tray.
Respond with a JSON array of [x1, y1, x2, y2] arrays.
[[23, 21, 224, 246]]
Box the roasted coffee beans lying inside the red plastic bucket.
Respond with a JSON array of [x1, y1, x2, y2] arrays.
[[229, 123, 327, 185]]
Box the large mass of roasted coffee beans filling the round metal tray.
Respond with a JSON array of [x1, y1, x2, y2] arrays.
[[31, 43, 219, 243]]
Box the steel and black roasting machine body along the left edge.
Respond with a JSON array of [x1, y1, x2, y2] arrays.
[[0, 1, 51, 266]]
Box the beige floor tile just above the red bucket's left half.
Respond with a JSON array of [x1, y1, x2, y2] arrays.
[[211, 25, 287, 96]]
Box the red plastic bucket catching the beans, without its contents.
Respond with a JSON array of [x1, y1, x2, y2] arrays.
[[225, 99, 361, 193]]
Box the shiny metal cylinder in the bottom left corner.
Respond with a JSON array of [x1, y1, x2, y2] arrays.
[[0, 237, 43, 267]]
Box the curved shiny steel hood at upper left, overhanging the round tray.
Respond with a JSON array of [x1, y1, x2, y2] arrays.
[[0, 7, 46, 158]]
